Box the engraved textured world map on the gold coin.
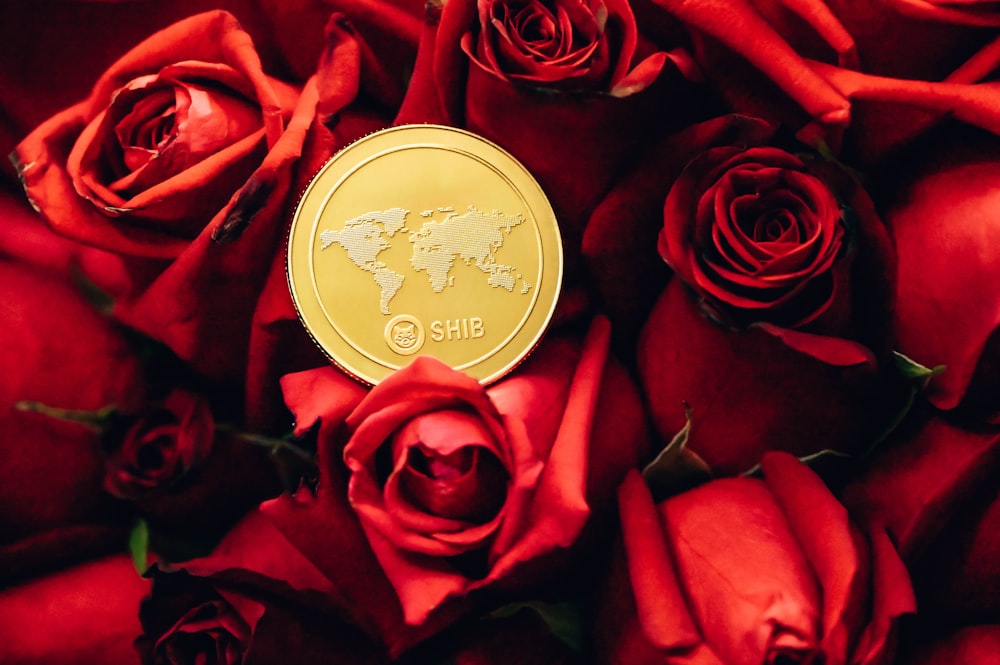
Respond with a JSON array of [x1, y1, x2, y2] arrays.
[[319, 205, 531, 314]]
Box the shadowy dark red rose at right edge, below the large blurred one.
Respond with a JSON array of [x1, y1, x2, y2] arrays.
[[843, 408, 1000, 622]]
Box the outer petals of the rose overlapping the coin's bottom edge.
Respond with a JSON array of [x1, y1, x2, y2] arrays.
[[266, 321, 646, 651]]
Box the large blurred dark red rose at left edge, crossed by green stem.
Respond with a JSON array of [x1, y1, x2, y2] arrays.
[[0, 261, 143, 577]]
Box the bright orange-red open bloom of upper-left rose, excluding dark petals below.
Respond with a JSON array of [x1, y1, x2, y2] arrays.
[[15, 12, 298, 258]]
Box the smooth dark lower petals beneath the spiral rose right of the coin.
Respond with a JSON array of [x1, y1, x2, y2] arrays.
[[639, 279, 879, 474]]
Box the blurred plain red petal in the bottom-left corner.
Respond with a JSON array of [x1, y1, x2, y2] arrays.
[[0, 554, 149, 665]]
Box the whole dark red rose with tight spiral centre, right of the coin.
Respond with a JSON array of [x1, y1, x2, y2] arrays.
[[639, 124, 895, 473]]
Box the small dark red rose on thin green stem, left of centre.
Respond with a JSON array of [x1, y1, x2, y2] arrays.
[[104, 390, 215, 499]]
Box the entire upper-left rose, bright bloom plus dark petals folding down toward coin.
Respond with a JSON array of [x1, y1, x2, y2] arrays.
[[14, 11, 382, 380]]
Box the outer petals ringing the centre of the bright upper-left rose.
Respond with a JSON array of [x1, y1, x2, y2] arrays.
[[16, 12, 297, 258]]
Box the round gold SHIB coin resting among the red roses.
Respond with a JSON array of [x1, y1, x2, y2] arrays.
[[288, 125, 562, 383]]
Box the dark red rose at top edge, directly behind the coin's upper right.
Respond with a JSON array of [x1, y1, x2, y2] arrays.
[[395, 0, 697, 275]]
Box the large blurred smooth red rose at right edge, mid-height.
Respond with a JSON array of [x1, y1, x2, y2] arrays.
[[885, 132, 1000, 420]]
